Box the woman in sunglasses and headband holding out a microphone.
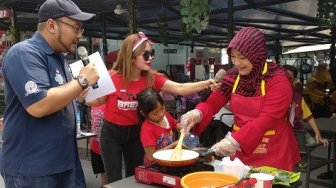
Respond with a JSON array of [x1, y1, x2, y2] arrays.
[[86, 32, 218, 183]]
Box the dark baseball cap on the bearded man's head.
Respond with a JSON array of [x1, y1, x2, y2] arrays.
[[38, 0, 95, 22]]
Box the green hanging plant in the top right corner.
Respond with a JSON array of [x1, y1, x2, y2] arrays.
[[316, 0, 336, 28]]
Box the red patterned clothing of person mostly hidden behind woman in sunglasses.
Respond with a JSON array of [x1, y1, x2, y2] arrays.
[[90, 104, 106, 154]]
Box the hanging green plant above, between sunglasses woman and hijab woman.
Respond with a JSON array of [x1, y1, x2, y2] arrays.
[[180, 0, 211, 39]]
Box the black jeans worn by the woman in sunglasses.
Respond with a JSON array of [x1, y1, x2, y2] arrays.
[[100, 121, 144, 183]]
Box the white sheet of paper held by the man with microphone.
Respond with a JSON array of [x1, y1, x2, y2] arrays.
[[70, 52, 116, 102]]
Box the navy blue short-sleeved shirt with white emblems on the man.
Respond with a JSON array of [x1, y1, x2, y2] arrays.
[[0, 32, 77, 176]]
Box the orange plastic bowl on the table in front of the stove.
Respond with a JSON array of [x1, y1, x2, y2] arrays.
[[181, 171, 239, 188]]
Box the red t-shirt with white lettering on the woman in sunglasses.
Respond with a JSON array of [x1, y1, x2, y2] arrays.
[[104, 71, 167, 126]]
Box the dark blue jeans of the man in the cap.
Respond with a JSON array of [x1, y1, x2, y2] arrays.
[[1, 169, 75, 188]]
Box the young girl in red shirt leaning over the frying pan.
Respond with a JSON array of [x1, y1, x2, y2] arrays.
[[137, 88, 180, 165]]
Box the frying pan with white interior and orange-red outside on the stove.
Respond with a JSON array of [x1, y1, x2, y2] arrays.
[[153, 148, 214, 167]]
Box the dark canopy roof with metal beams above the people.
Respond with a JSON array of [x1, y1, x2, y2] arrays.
[[0, 0, 330, 51]]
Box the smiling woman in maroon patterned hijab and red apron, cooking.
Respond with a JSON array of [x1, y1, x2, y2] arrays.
[[181, 27, 300, 171]]
